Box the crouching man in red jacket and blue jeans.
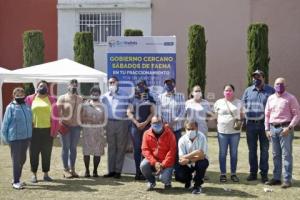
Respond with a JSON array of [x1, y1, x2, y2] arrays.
[[140, 116, 176, 190]]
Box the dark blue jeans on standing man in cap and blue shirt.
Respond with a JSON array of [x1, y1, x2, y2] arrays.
[[246, 121, 269, 176]]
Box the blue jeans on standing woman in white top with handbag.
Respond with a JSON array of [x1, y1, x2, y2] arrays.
[[218, 133, 240, 174]]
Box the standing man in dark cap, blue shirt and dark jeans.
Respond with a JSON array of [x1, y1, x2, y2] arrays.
[[242, 70, 275, 183]]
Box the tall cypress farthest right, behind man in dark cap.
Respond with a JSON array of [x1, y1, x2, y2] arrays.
[[247, 23, 270, 86]]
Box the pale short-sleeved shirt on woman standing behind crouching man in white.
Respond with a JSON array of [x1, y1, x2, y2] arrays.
[[185, 99, 212, 134]]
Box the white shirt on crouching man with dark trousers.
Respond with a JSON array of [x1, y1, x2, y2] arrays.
[[178, 131, 208, 166]]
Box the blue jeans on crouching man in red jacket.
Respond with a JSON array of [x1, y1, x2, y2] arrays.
[[140, 159, 173, 185]]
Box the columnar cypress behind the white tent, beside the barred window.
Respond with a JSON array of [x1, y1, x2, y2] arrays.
[[73, 32, 94, 96]]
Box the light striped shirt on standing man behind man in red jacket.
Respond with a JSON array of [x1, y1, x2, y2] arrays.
[[157, 92, 185, 131]]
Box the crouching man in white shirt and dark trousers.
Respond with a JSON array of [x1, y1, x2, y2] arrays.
[[175, 121, 209, 194]]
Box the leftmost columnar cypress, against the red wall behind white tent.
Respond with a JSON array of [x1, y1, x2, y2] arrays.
[[23, 30, 45, 95]]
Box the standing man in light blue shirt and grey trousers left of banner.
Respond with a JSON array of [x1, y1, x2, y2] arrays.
[[101, 76, 131, 179]]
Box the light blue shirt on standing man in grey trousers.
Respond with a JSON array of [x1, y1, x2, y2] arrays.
[[101, 90, 132, 120]]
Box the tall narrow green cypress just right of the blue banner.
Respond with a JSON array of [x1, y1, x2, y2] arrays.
[[188, 25, 206, 95]]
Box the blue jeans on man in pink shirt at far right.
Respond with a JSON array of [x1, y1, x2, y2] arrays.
[[270, 125, 294, 183]]
